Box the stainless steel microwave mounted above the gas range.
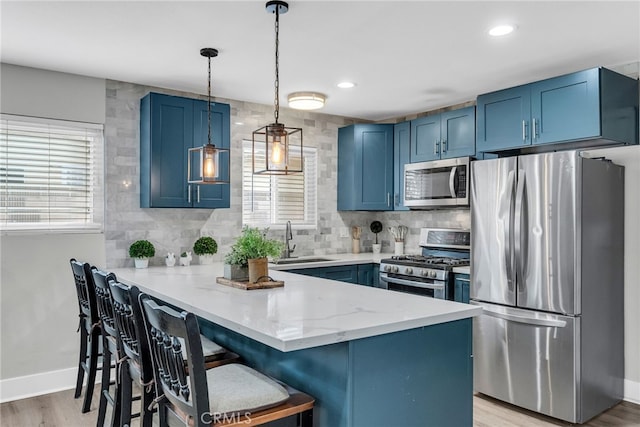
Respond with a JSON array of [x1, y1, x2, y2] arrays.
[[404, 157, 471, 209]]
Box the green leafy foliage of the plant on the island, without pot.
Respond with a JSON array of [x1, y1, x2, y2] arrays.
[[224, 226, 284, 266]]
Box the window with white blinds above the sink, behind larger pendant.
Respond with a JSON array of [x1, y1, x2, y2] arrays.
[[242, 141, 318, 228]]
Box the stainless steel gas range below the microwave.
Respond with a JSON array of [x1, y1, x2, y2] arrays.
[[380, 228, 471, 299]]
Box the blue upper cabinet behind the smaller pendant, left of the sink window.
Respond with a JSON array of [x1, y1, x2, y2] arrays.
[[140, 93, 230, 208]]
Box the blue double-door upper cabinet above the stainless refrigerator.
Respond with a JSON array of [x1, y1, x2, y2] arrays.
[[477, 68, 638, 152]]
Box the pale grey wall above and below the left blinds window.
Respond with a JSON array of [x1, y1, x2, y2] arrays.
[[0, 64, 106, 401]]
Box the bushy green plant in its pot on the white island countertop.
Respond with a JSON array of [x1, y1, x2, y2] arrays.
[[225, 226, 284, 283]]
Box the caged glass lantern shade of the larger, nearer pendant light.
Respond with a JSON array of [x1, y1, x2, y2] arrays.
[[253, 123, 302, 175]]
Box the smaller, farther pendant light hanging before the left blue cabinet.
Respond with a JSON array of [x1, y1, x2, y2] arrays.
[[187, 47, 229, 184]]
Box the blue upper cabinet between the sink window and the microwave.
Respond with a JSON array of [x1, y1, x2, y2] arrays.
[[338, 124, 394, 211]]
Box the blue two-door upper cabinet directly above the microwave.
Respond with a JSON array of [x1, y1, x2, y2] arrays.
[[410, 107, 476, 163]]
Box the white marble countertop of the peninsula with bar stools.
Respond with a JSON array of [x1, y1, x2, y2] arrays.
[[112, 262, 482, 351]]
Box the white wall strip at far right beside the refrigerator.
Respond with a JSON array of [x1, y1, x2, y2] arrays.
[[585, 145, 640, 403]]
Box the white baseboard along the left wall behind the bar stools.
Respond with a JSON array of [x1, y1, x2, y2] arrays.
[[0, 368, 100, 403]]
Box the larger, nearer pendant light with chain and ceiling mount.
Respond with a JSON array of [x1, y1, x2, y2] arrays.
[[252, 0, 302, 175]]
